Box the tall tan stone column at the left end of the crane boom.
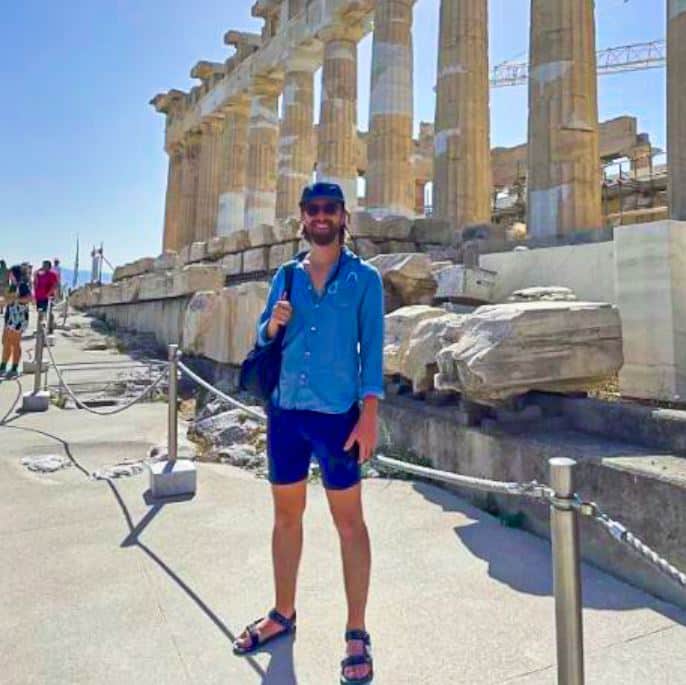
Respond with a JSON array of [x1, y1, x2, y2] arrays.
[[433, 0, 492, 231]]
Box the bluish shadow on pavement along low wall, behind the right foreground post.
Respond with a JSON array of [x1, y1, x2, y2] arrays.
[[414, 481, 686, 625]]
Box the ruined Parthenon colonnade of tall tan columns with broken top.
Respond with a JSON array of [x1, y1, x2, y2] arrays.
[[151, 0, 686, 251]]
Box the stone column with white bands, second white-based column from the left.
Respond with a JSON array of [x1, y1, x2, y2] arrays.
[[245, 79, 281, 229]]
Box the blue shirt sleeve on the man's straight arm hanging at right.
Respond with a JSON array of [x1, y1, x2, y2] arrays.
[[359, 269, 384, 399]]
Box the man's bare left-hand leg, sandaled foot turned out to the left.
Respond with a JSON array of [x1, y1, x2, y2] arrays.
[[236, 480, 307, 647]]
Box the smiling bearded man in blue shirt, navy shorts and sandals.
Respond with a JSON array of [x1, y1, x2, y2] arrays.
[[234, 183, 384, 685]]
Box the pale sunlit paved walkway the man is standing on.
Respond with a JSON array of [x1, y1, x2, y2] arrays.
[[0, 314, 686, 685]]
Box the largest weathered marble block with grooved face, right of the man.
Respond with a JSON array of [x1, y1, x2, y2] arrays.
[[435, 302, 623, 404]]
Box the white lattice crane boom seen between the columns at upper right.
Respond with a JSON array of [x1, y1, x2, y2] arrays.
[[491, 40, 667, 88]]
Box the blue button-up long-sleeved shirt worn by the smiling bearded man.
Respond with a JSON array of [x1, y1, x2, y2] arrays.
[[257, 248, 384, 414]]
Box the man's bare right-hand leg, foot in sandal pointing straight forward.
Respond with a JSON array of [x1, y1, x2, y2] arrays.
[[326, 483, 371, 678]]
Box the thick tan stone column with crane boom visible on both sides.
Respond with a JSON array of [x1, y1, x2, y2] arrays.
[[527, 0, 602, 236]]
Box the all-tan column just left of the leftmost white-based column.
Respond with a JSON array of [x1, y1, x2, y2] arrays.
[[195, 118, 223, 241]]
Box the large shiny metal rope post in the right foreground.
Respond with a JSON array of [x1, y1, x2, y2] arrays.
[[548, 458, 584, 685]]
